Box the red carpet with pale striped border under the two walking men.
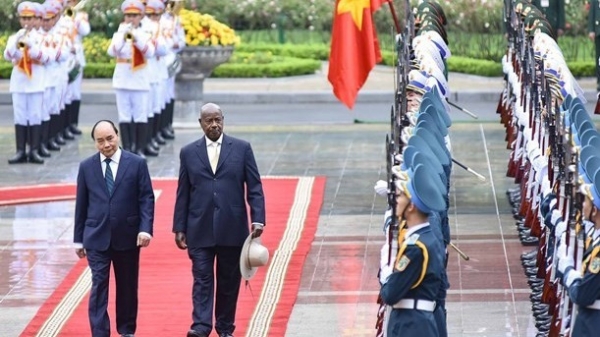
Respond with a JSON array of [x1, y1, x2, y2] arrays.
[[16, 177, 325, 336]]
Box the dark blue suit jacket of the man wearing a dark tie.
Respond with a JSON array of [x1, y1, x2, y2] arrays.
[[74, 150, 154, 251]]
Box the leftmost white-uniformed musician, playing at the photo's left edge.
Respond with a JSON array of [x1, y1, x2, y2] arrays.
[[4, 1, 48, 164]]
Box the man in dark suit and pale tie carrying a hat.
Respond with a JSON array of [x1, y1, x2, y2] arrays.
[[173, 103, 265, 337]]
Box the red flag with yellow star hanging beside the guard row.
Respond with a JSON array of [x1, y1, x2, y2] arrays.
[[327, 0, 388, 109]]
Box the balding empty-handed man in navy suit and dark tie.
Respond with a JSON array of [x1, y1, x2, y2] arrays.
[[74, 120, 154, 337]]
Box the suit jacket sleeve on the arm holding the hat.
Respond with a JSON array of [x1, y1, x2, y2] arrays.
[[244, 144, 267, 225]]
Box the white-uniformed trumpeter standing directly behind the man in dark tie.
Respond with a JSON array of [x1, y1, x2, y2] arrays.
[[108, 0, 156, 157]]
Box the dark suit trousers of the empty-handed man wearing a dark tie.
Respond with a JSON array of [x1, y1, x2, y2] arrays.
[[86, 247, 140, 337]]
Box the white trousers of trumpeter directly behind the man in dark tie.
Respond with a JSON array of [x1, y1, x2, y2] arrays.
[[115, 89, 150, 123]]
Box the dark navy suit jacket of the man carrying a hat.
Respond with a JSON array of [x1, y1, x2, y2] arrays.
[[173, 134, 266, 248]]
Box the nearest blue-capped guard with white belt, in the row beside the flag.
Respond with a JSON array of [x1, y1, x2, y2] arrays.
[[380, 164, 446, 337]]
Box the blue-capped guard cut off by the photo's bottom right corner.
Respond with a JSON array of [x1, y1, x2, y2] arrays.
[[556, 167, 600, 337]]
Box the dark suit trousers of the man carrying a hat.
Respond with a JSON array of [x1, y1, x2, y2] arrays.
[[188, 246, 242, 334]]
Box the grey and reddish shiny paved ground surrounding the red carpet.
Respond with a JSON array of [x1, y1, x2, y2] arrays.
[[0, 68, 593, 337]]
